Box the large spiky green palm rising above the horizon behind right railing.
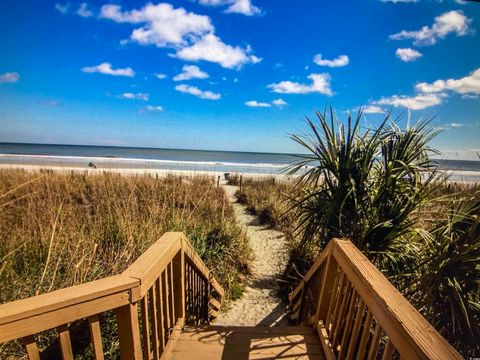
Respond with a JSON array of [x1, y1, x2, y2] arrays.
[[288, 109, 438, 276]]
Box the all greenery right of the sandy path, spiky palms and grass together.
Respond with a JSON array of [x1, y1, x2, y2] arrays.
[[234, 112, 480, 356]]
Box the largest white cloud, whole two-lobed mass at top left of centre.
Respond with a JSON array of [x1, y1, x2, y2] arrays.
[[100, 3, 261, 69]]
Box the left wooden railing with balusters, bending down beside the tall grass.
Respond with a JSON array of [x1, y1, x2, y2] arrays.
[[0, 232, 224, 359]]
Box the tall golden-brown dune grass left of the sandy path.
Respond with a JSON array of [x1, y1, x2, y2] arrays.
[[0, 170, 250, 358]]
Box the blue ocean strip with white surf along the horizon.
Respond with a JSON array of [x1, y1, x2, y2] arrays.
[[0, 143, 480, 182]]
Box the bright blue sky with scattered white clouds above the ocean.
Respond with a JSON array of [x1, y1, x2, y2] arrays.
[[0, 0, 480, 159]]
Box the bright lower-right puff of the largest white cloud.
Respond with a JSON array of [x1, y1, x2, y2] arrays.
[[173, 33, 261, 69]]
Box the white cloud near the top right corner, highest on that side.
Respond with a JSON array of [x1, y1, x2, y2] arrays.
[[390, 10, 472, 45]]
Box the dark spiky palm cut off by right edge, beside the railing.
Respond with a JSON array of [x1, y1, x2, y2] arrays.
[[412, 190, 480, 356]]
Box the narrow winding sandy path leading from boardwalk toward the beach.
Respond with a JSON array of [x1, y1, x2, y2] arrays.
[[215, 185, 287, 326]]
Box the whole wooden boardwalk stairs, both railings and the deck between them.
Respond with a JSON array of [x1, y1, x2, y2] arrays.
[[0, 233, 461, 360]]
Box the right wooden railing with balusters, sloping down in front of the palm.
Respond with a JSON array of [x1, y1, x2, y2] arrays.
[[290, 239, 462, 360]]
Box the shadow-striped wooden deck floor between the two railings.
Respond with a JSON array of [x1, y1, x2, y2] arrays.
[[170, 326, 325, 360]]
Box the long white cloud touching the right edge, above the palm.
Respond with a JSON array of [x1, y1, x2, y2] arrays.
[[415, 68, 480, 94]]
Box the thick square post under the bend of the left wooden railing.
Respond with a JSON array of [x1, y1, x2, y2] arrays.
[[115, 303, 142, 360]]
